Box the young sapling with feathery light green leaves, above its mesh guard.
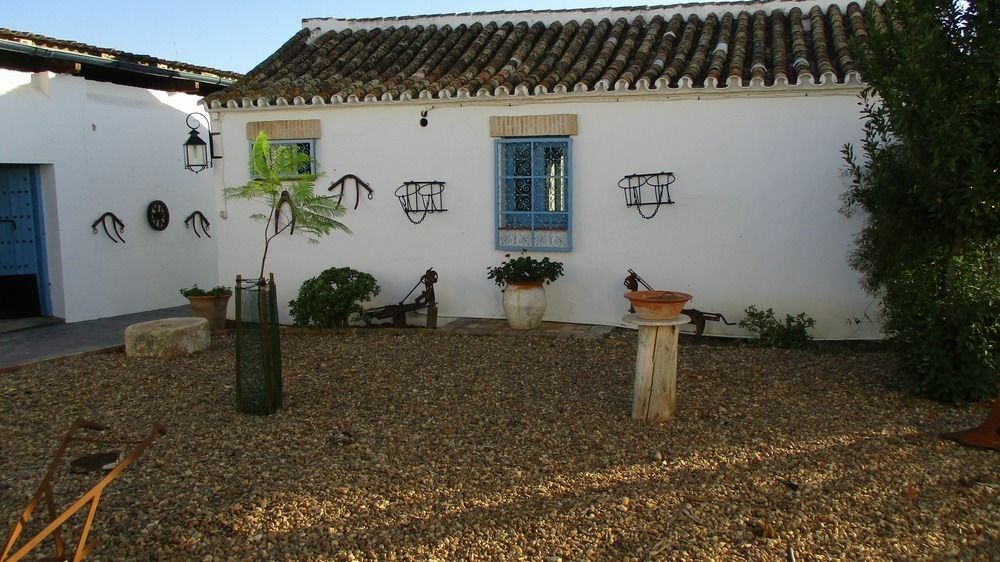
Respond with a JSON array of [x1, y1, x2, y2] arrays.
[[222, 133, 351, 279]]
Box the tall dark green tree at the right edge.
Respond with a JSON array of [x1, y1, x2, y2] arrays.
[[843, 0, 1000, 401]]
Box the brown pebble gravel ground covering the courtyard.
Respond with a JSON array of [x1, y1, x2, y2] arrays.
[[0, 330, 1000, 561]]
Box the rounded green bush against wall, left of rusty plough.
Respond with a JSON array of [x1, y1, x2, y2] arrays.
[[288, 267, 381, 328]]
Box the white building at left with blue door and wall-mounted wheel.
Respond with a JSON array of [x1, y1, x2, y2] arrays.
[[0, 29, 237, 322]]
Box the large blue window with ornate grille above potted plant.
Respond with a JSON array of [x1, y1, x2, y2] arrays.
[[496, 137, 573, 252]]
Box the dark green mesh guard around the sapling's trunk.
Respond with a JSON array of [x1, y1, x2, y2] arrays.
[[236, 273, 281, 415]]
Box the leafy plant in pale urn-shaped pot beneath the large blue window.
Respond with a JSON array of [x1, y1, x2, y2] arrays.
[[486, 250, 563, 330]]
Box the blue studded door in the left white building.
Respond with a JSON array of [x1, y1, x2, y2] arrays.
[[0, 165, 51, 318]]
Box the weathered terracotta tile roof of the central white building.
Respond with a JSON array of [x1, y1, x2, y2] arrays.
[[206, 1, 884, 107]]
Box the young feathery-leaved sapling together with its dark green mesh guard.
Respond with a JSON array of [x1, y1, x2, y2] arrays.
[[222, 133, 350, 414]]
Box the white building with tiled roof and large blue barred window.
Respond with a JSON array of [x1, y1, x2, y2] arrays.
[[206, 1, 878, 339]]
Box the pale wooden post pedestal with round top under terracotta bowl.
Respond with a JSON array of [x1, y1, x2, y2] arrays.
[[622, 314, 691, 423]]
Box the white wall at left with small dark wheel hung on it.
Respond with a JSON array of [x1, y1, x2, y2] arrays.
[[0, 70, 218, 322]]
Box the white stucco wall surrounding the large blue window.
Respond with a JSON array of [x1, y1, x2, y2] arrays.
[[215, 91, 878, 339]]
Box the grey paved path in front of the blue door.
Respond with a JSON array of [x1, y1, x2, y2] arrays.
[[0, 305, 191, 370]]
